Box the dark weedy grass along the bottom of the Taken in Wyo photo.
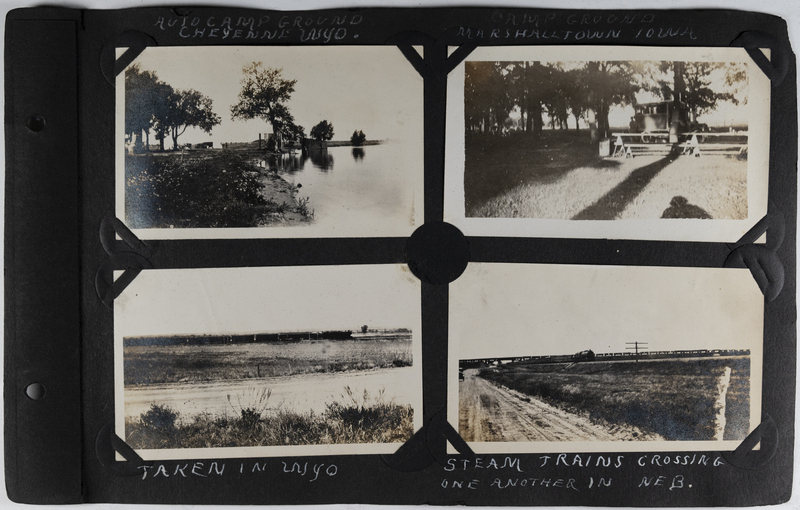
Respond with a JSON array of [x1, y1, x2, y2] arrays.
[[125, 387, 414, 449]]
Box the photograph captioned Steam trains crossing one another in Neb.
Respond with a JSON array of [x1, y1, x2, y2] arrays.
[[448, 264, 763, 453]]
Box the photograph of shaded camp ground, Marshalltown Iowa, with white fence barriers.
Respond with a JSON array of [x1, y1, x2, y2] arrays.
[[448, 48, 769, 240]]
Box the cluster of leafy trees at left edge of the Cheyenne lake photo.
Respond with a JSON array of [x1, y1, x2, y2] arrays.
[[125, 64, 221, 150]]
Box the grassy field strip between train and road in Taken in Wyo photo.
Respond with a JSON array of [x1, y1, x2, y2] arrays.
[[123, 338, 412, 386]]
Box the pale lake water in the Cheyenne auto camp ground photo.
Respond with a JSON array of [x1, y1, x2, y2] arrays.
[[262, 143, 422, 235]]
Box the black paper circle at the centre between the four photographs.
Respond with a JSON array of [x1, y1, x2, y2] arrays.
[[406, 221, 469, 285]]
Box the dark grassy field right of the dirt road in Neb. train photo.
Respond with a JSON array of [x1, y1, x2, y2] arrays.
[[480, 358, 750, 440]]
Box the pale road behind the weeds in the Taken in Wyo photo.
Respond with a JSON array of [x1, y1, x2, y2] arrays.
[[125, 367, 419, 417]]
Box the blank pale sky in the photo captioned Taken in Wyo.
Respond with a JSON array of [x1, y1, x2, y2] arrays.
[[114, 264, 421, 337]]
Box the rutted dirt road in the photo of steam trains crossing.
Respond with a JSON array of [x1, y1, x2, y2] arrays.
[[458, 369, 660, 442]]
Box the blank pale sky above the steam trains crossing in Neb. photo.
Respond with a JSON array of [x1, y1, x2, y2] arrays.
[[450, 264, 764, 359]]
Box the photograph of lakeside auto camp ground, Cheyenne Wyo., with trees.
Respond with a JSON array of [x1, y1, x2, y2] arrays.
[[116, 46, 423, 238]]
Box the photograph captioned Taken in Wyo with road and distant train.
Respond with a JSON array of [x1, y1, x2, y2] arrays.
[[114, 265, 422, 459]]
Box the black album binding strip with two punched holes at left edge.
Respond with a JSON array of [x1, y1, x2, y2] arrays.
[[4, 9, 82, 504]]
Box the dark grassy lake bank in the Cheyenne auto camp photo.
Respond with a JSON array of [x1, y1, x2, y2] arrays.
[[125, 150, 313, 228]]
